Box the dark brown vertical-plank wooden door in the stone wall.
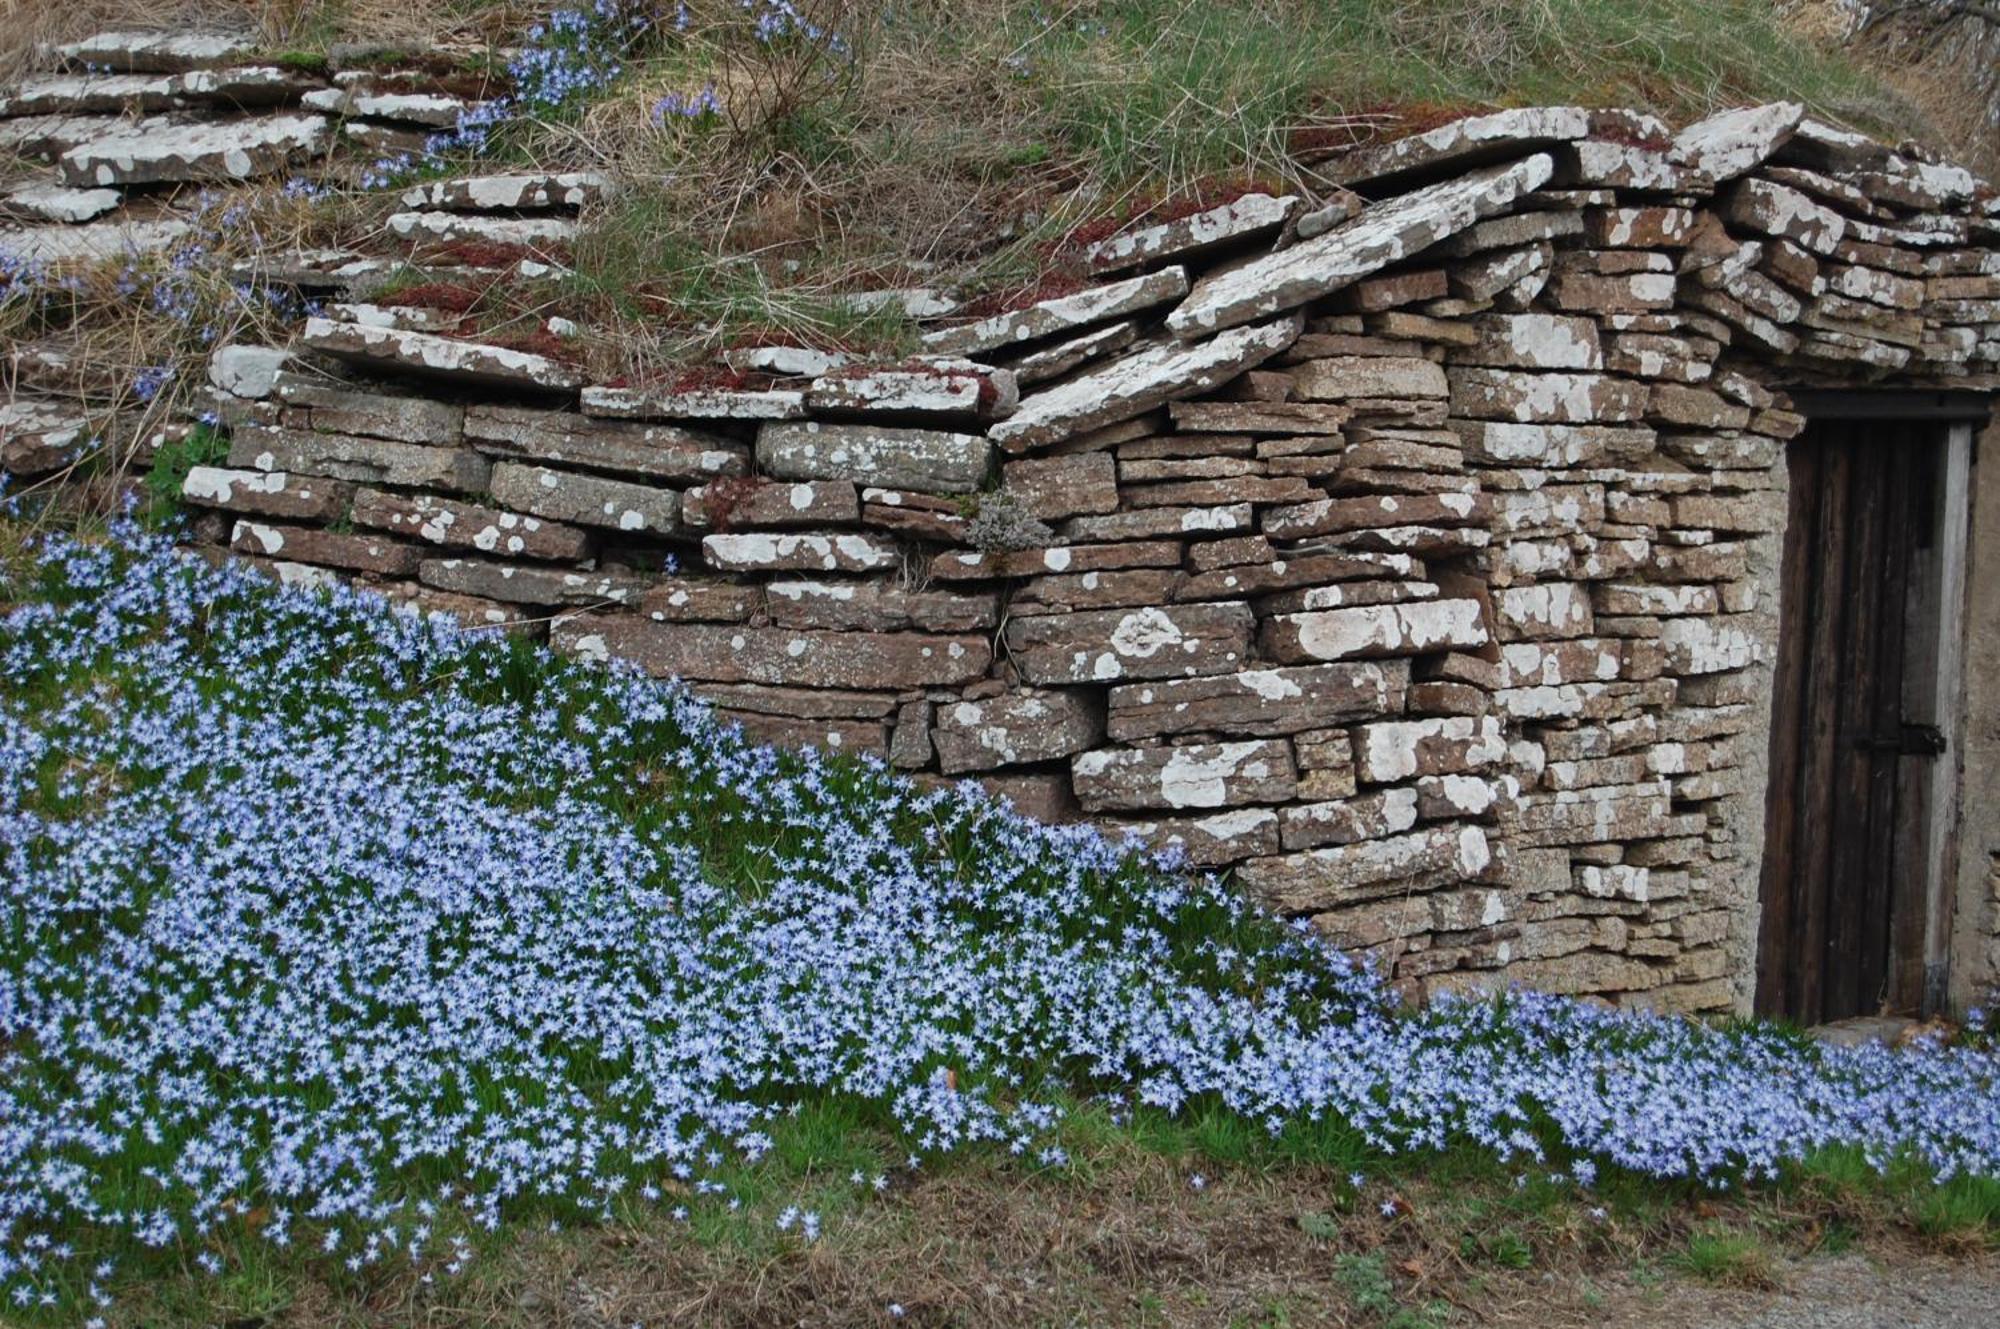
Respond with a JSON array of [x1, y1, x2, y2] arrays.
[[1756, 418, 1946, 1025]]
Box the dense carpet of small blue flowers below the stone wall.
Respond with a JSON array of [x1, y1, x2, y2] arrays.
[[0, 534, 2000, 1313]]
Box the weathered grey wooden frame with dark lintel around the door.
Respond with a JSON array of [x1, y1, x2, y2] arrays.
[[1752, 388, 1992, 1017]]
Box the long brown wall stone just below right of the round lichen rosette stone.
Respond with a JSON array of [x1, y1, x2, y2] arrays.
[[1106, 660, 1410, 741]]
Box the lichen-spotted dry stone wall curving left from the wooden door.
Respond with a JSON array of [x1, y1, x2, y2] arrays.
[[10, 83, 2000, 1011]]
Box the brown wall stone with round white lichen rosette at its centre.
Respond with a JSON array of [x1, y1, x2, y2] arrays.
[[1006, 600, 1254, 685]]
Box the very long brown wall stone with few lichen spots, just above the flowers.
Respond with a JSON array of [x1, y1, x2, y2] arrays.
[[550, 614, 992, 693]]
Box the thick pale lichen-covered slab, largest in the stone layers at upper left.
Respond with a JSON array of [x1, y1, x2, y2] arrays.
[[56, 114, 332, 186]]
